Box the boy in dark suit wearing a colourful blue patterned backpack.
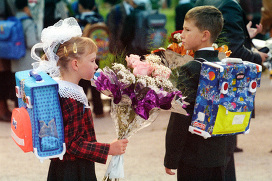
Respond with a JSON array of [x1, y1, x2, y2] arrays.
[[164, 6, 227, 181]]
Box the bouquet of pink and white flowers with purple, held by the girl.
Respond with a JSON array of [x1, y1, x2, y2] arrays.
[[94, 54, 187, 180]]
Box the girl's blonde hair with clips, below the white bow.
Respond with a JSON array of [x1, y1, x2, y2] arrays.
[[56, 37, 97, 72]]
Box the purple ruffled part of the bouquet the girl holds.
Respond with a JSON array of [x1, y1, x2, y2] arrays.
[[95, 65, 187, 120]]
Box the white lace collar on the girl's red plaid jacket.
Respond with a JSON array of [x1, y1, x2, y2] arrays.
[[55, 79, 90, 108]]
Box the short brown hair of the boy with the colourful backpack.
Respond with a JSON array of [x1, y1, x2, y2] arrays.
[[184, 6, 224, 42]]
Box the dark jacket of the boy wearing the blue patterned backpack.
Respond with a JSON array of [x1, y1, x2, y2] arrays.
[[164, 50, 228, 169]]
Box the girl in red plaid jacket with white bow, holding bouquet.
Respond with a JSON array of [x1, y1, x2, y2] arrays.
[[32, 18, 128, 181]]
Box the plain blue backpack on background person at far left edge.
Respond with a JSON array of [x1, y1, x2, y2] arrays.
[[0, 16, 30, 59]]
